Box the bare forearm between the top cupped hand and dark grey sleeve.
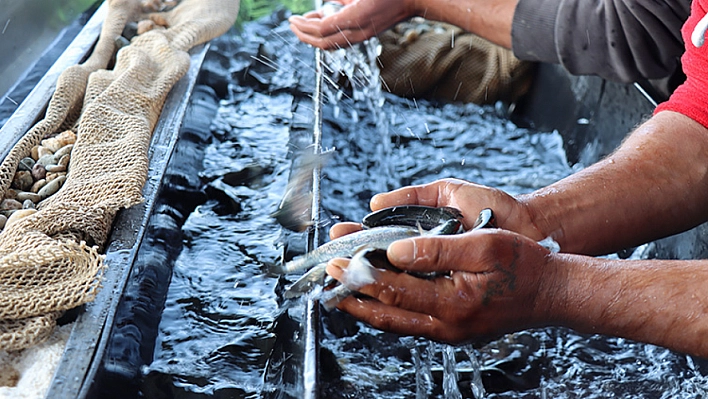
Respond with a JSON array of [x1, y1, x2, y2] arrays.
[[413, 0, 519, 49]]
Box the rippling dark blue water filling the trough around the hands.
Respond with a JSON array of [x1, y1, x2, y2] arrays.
[[133, 8, 708, 399]]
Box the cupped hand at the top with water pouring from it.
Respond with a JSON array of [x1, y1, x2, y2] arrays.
[[290, 0, 414, 50]]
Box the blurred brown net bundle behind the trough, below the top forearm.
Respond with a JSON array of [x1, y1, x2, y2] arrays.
[[379, 18, 533, 104]]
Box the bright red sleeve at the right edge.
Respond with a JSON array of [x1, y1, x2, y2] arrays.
[[654, 0, 708, 128]]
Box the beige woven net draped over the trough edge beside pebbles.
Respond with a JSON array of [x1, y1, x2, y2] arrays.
[[0, 0, 239, 350]]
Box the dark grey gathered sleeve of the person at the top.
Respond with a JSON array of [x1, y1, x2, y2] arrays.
[[512, 0, 691, 83]]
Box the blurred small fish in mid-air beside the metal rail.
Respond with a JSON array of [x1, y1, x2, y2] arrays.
[[270, 151, 332, 233]]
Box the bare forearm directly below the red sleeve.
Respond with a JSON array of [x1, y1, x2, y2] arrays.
[[519, 112, 708, 255]]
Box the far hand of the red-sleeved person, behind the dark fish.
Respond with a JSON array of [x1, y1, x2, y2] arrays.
[[370, 179, 546, 241]]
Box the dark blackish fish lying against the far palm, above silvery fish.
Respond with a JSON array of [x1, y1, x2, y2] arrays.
[[362, 205, 462, 230]]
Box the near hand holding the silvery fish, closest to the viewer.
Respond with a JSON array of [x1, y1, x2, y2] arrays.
[[327, 229, 563, 343]]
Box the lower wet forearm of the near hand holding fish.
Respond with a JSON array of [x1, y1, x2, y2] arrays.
[[548, 254, 708, 357]]
